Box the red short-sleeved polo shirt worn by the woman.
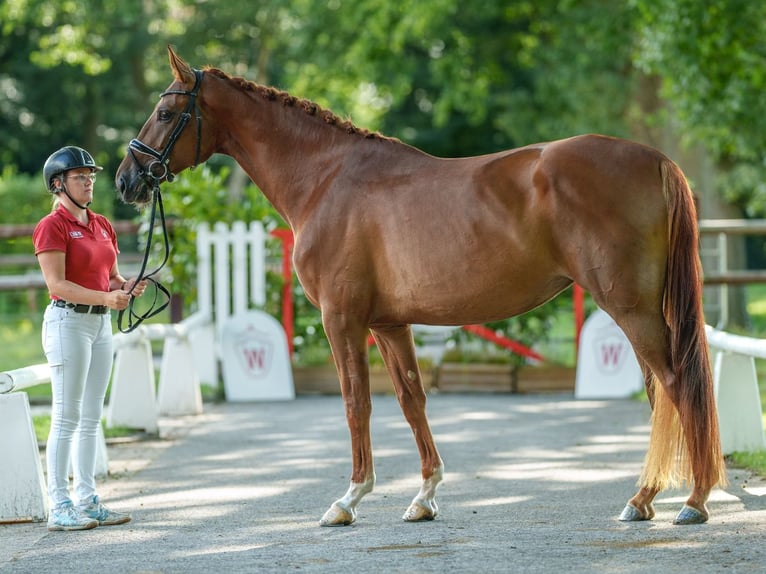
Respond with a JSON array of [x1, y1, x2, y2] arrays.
[[32, 205, 120, 299]]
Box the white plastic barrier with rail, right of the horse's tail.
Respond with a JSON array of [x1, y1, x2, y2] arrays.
[[706, 326, 766, 454]]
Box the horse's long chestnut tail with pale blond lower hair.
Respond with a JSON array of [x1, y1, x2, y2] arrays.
[[639, 159, 726, 490]]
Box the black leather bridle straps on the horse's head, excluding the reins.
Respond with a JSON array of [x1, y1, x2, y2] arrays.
[[128, 70, 202, 188]]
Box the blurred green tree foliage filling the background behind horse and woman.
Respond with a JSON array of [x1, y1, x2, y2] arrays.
[[0, 0, 766, 364]]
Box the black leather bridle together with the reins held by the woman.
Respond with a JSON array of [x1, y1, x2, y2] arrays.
[[117, 70, 202, 333]]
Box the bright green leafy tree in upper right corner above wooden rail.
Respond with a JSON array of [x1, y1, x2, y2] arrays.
[[632, 0, 766, 217]]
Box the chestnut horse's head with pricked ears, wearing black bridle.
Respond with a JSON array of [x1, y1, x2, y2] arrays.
[[115, 46, 212, 204]]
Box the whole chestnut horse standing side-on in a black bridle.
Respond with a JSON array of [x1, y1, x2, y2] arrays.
[[115, 47, 726, 526]]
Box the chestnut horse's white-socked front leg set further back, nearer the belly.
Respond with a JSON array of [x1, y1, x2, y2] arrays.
[[372, 325, 444, 522]]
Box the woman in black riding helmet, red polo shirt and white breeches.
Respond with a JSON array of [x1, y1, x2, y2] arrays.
[[33, 146, 146, 530]]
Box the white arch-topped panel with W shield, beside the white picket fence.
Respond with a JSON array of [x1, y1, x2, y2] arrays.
[[221, 310, 295, 402]]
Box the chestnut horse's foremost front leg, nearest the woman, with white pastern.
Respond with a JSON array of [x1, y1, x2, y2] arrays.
[[319, 310, 375, 526]]
